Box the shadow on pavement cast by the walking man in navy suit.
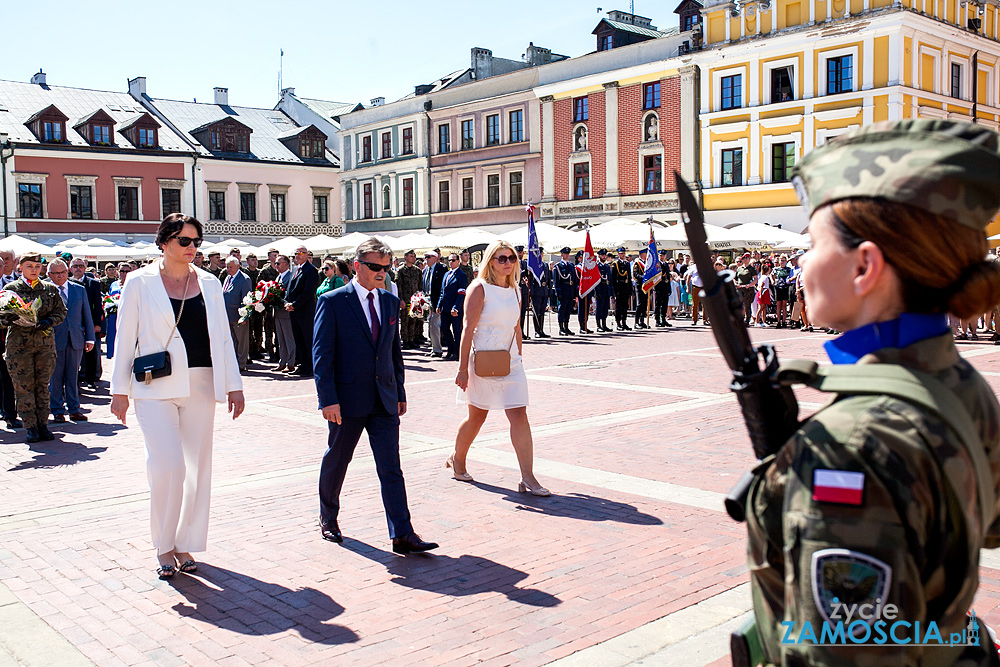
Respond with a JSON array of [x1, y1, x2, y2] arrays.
[[344, 537, 562, 607]]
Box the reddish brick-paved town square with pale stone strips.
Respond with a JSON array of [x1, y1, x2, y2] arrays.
[[0, 320, 1000, 667]]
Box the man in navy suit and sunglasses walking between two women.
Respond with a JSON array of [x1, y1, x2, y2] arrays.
[[312, 239, 438, 554]]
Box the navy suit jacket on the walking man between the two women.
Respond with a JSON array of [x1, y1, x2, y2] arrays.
[[313, 282, 406, 417]]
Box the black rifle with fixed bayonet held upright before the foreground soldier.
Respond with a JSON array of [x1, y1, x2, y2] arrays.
[[674, 171, 799, 521]]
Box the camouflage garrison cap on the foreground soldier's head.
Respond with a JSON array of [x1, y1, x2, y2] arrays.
[[792, 120, 1000, 229]]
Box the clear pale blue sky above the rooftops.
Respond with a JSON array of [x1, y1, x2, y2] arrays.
[[0, 0, 679, 107]]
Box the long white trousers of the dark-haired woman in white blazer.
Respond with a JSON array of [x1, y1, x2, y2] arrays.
[[135, 368, 215, 554]]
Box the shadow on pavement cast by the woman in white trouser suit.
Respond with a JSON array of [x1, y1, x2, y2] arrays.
[[169, 563, 359, 645]]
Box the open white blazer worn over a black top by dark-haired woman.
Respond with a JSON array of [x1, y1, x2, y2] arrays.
[[111, 262, 243, 403]]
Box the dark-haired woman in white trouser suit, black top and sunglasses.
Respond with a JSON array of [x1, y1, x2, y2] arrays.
[[111, 213, 244, 579]]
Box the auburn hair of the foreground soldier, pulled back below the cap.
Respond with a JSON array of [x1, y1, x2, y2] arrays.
[[830, 199, 1000, 319]]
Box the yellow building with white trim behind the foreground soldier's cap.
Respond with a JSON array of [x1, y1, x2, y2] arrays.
[[695, 0, 1000, 233]]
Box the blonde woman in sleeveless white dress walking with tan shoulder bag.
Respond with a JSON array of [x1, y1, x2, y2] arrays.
[[445, 240, 551, 496]]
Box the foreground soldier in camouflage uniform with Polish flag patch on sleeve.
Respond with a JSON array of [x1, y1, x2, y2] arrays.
[[746, 120, 1000, 667]]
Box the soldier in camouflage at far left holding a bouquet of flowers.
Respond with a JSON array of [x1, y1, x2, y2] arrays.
[[4, 255, 66, 443]]
